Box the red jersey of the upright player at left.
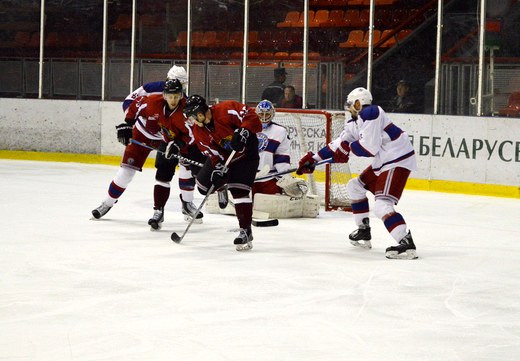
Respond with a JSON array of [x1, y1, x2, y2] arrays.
[[126, 94, 194, 148]]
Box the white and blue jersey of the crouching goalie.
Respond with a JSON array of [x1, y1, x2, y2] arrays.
[[256, 123, 291, 181]]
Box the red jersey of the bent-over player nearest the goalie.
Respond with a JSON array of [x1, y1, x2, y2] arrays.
[[193, 100, 262, 163]]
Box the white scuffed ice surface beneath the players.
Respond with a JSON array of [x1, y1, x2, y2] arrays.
[[0, 160, 520, 361]]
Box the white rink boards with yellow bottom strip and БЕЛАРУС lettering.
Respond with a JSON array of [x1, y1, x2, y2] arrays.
[[0, 98, 520, 198]]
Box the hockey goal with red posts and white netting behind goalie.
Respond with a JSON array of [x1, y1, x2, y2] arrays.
[[274, 109, 351, 211]]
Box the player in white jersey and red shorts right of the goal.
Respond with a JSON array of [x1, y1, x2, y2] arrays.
[[297, 88, 417, 259]]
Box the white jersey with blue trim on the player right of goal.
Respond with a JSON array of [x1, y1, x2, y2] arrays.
[[318, 105, 417, 175]]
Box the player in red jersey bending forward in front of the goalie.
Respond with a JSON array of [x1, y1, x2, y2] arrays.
[[184, 95, 262, 251]]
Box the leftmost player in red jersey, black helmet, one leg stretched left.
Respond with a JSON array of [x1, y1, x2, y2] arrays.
[[92, 79, 205, 229]]
